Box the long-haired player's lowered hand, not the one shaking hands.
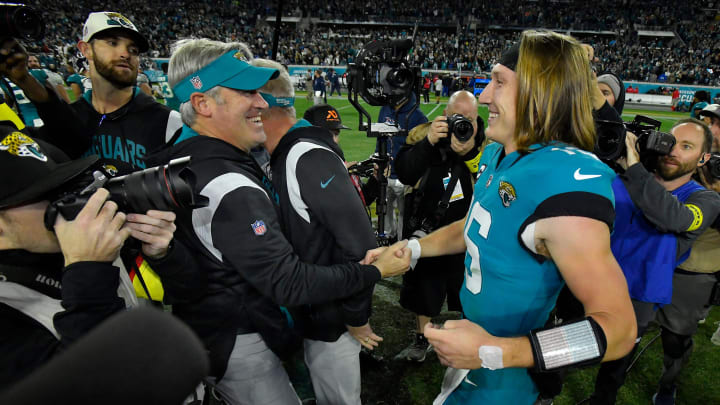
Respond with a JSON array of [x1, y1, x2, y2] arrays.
[[424, 319, 486, 370]]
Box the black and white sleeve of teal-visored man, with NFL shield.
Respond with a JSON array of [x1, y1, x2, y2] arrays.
[[192, 173, 380, 306]]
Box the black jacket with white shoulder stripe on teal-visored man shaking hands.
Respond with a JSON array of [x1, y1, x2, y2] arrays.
[[160, 136, 380, 376]]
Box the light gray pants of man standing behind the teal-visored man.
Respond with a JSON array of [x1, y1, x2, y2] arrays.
[[304, 332, 361, 405]]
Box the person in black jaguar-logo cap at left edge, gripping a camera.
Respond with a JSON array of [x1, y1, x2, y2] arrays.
[[0, 126, 131, 391]]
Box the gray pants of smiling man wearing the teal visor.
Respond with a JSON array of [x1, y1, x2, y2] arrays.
[[215, 333, 300, 405]]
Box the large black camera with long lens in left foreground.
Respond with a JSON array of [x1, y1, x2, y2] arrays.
[[45, 156, 208, 230]]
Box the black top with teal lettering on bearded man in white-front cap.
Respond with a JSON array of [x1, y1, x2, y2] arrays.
[[35, 89, 182, 174]]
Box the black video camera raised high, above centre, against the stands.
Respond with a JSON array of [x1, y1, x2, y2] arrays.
[[348, 39, 421, 106]]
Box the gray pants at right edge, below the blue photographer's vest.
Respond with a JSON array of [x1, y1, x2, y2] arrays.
[[657, 273, 716, 388]]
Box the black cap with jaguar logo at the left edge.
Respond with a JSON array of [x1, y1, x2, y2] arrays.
[[0, 125, 99, 210]]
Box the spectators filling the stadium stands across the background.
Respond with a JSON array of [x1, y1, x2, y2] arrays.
[[19, 0, 720, 85]]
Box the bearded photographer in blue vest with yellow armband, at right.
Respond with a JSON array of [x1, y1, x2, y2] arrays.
[[591, 118, 720, 404]]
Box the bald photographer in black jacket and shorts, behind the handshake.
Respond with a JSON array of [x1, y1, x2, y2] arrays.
[[395, 91, 485, 362]]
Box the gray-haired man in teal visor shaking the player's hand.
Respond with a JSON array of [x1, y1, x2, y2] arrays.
[[168, 39, 409, 405]]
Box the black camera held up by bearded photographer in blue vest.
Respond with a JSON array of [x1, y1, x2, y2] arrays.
[[595, 115, 675, 170]]
